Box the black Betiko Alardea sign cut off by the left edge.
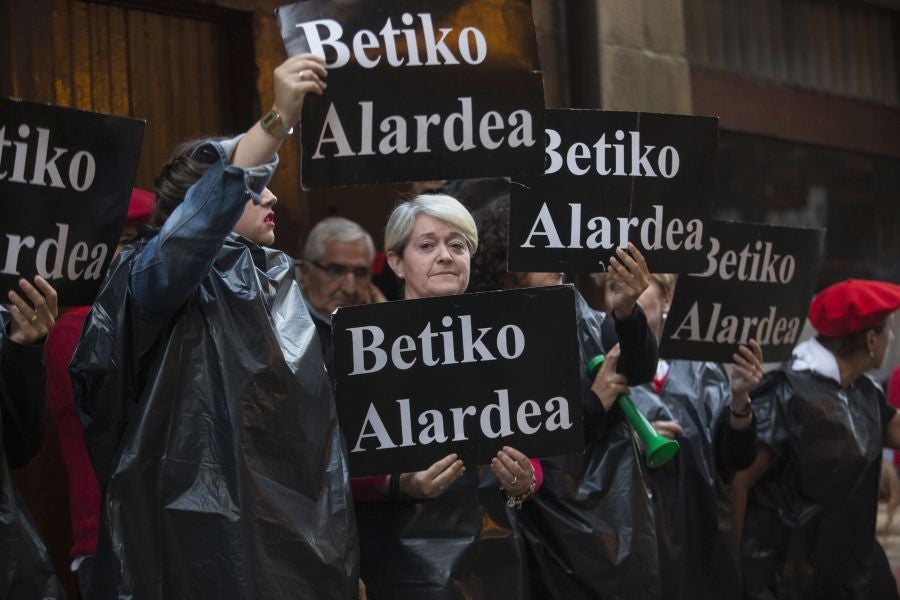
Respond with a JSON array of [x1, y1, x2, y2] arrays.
[[0, 98, 144, 306]]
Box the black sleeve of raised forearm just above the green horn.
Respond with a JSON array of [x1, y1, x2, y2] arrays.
[[601, 305, 659, 385]]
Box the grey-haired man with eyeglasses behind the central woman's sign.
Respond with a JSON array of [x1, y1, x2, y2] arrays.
[[297, 217, 385, 374]]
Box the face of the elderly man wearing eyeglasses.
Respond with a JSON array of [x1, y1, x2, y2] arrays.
[[300, 240, 373, 315]]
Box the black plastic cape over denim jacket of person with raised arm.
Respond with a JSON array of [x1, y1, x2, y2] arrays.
[[70, 234, 358, 600]]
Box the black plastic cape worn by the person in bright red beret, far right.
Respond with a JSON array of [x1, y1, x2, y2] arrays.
[[741, 358, 885, 600]]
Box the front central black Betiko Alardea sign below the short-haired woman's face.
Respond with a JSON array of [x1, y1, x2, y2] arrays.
[[332, 286, 584, 477]]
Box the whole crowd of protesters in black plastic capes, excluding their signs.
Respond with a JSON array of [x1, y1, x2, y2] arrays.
[[0, 55, 900, 600]]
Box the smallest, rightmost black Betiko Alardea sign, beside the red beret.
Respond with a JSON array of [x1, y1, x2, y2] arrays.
[[659, 221, 825, 363]]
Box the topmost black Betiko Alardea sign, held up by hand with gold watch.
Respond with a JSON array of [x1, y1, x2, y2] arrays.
[[278, 0, 544, 188]]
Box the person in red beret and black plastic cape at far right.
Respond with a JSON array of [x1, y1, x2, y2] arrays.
[[735, 280, 900, 600]]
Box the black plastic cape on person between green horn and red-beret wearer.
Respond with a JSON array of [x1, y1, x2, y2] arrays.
[[631, 360, 756, 600]]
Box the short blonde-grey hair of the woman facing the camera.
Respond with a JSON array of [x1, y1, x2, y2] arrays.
[[384, 194, 478, 256]]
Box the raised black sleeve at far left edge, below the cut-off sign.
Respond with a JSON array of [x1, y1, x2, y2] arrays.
[[0, 309, 47, 469]]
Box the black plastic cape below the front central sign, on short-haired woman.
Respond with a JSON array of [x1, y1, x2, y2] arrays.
[[356, 464, 532, 600]]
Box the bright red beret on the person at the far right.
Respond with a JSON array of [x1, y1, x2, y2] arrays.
[[809, 279, 900, 337]]
